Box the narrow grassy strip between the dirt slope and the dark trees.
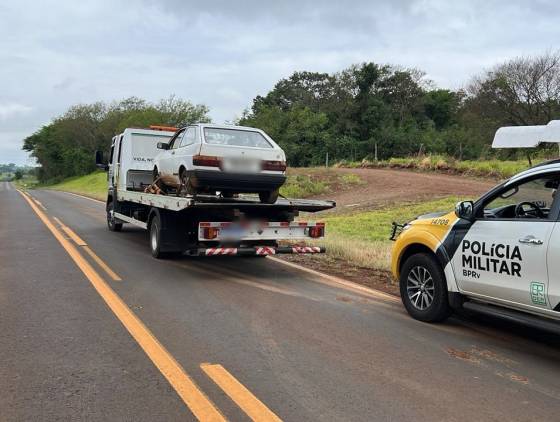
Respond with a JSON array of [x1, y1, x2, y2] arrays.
[[337, 155, 543, 179]]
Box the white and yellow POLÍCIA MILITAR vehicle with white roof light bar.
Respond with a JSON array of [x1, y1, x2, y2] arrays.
[[391, 121, 560, 332]]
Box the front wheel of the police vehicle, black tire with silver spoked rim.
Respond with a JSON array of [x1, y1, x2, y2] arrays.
[[400, 253, 451, 322]]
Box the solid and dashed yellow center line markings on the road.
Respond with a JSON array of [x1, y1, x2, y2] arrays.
[[19, 191, 280, 421]]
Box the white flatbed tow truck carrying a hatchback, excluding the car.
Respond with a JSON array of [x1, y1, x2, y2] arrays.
[[96, 126, 336, 258]]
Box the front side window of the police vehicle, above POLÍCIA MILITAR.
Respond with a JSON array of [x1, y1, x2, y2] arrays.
[[479, 175, 560, 220]]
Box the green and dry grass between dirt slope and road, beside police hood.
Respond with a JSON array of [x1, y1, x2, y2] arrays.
[[308, 197, 462, 270]]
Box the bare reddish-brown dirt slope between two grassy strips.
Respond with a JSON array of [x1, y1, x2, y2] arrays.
[[319, 169, 497, 212]]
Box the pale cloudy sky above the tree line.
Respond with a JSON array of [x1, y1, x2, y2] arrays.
[[0, 0, 560, 164]]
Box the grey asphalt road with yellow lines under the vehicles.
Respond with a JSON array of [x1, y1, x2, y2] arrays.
[[0, 183, 560, 421]]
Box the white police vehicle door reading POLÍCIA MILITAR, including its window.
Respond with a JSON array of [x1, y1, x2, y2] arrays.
[[452, 174, 559, 309]]
